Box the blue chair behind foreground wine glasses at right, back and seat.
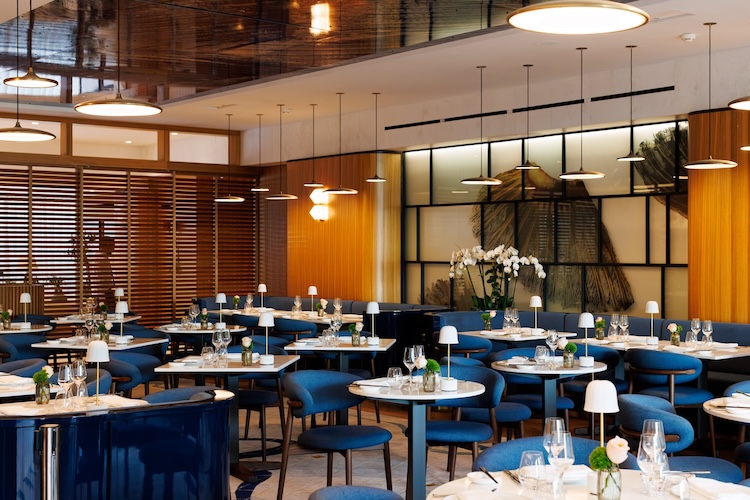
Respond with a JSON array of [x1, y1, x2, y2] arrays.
[[618, 394, 743, 483]]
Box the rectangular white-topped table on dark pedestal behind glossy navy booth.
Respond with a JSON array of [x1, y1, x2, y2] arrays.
[[154, 353, 300, 481]]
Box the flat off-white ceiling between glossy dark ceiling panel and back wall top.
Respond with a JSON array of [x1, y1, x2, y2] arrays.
[[13, 0, 750, 134]]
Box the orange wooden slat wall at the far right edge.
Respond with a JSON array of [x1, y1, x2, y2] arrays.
[[688, 110, 750, 323]]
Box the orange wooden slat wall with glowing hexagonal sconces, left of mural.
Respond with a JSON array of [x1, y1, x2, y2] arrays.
[[287, 153, 401, 300]]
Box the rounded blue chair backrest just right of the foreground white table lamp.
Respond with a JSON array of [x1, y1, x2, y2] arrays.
[[617, 394, 695, 453]]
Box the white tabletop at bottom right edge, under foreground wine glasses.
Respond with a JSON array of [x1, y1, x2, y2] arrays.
[[427, 469, 750, 500]]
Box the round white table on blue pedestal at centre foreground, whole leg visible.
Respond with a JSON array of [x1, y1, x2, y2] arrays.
[[349, 379, 485, 500]]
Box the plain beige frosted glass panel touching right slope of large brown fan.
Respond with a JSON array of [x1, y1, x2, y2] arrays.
[[601, 197, 647, 264]]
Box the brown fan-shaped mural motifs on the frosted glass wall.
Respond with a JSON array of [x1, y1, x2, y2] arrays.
[[420, 123, 687, 312]]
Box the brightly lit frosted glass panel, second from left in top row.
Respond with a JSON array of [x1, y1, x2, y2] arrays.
[[432, 144, 490, 204]]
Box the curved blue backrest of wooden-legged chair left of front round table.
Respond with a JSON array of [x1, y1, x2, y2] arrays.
[[283, 370, 364, 417]]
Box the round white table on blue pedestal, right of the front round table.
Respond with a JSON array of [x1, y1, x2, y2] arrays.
[[491, 356, 607, 418]]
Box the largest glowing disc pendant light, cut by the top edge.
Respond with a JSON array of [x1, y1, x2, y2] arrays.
[[507, 0, 650, 35]]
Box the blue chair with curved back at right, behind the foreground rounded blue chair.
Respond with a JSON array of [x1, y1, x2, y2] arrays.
[[625, 349, 714, 407]]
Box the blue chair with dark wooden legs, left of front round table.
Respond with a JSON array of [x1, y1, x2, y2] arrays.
[[277, 370, 393, 500]]
